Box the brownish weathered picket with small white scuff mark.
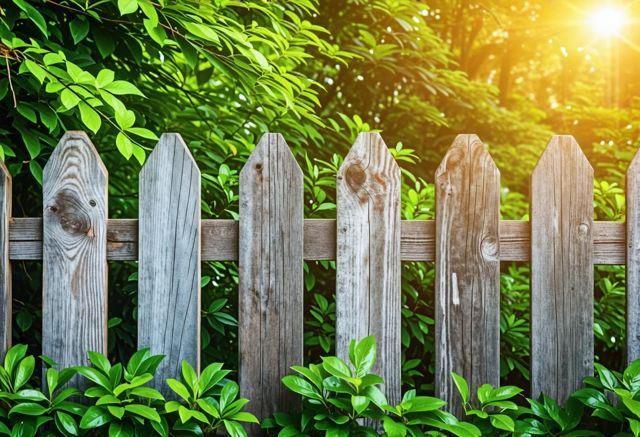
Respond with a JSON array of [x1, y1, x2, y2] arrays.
[[435, 135, 500, 416]]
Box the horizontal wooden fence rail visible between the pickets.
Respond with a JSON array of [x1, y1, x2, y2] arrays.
[[9, 217, 626, 265]]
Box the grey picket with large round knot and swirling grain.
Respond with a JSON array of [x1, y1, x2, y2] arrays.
[[42, 132, 107, 379]]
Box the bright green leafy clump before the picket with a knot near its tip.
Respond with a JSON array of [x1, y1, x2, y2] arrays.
[[262, 337, 480, 436]]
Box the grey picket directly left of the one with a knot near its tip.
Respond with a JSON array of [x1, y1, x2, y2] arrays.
[[238, 134, 304, 422]]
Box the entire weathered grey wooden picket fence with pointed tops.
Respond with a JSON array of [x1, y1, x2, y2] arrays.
[[0, 132, 640, 417]]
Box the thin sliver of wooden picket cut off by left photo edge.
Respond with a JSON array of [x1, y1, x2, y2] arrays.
[[0, 161, 12, 360]]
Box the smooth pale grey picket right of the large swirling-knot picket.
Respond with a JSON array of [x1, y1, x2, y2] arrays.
[[138, 133, 200, 397]]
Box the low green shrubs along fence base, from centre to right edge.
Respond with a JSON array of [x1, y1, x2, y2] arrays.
[[274, 337, 640, 437]]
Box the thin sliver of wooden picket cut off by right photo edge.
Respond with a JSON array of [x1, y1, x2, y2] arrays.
[[626, 152, 640, 363]]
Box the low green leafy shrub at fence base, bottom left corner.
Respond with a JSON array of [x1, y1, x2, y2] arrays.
[[0, 345, 258, 437]]
